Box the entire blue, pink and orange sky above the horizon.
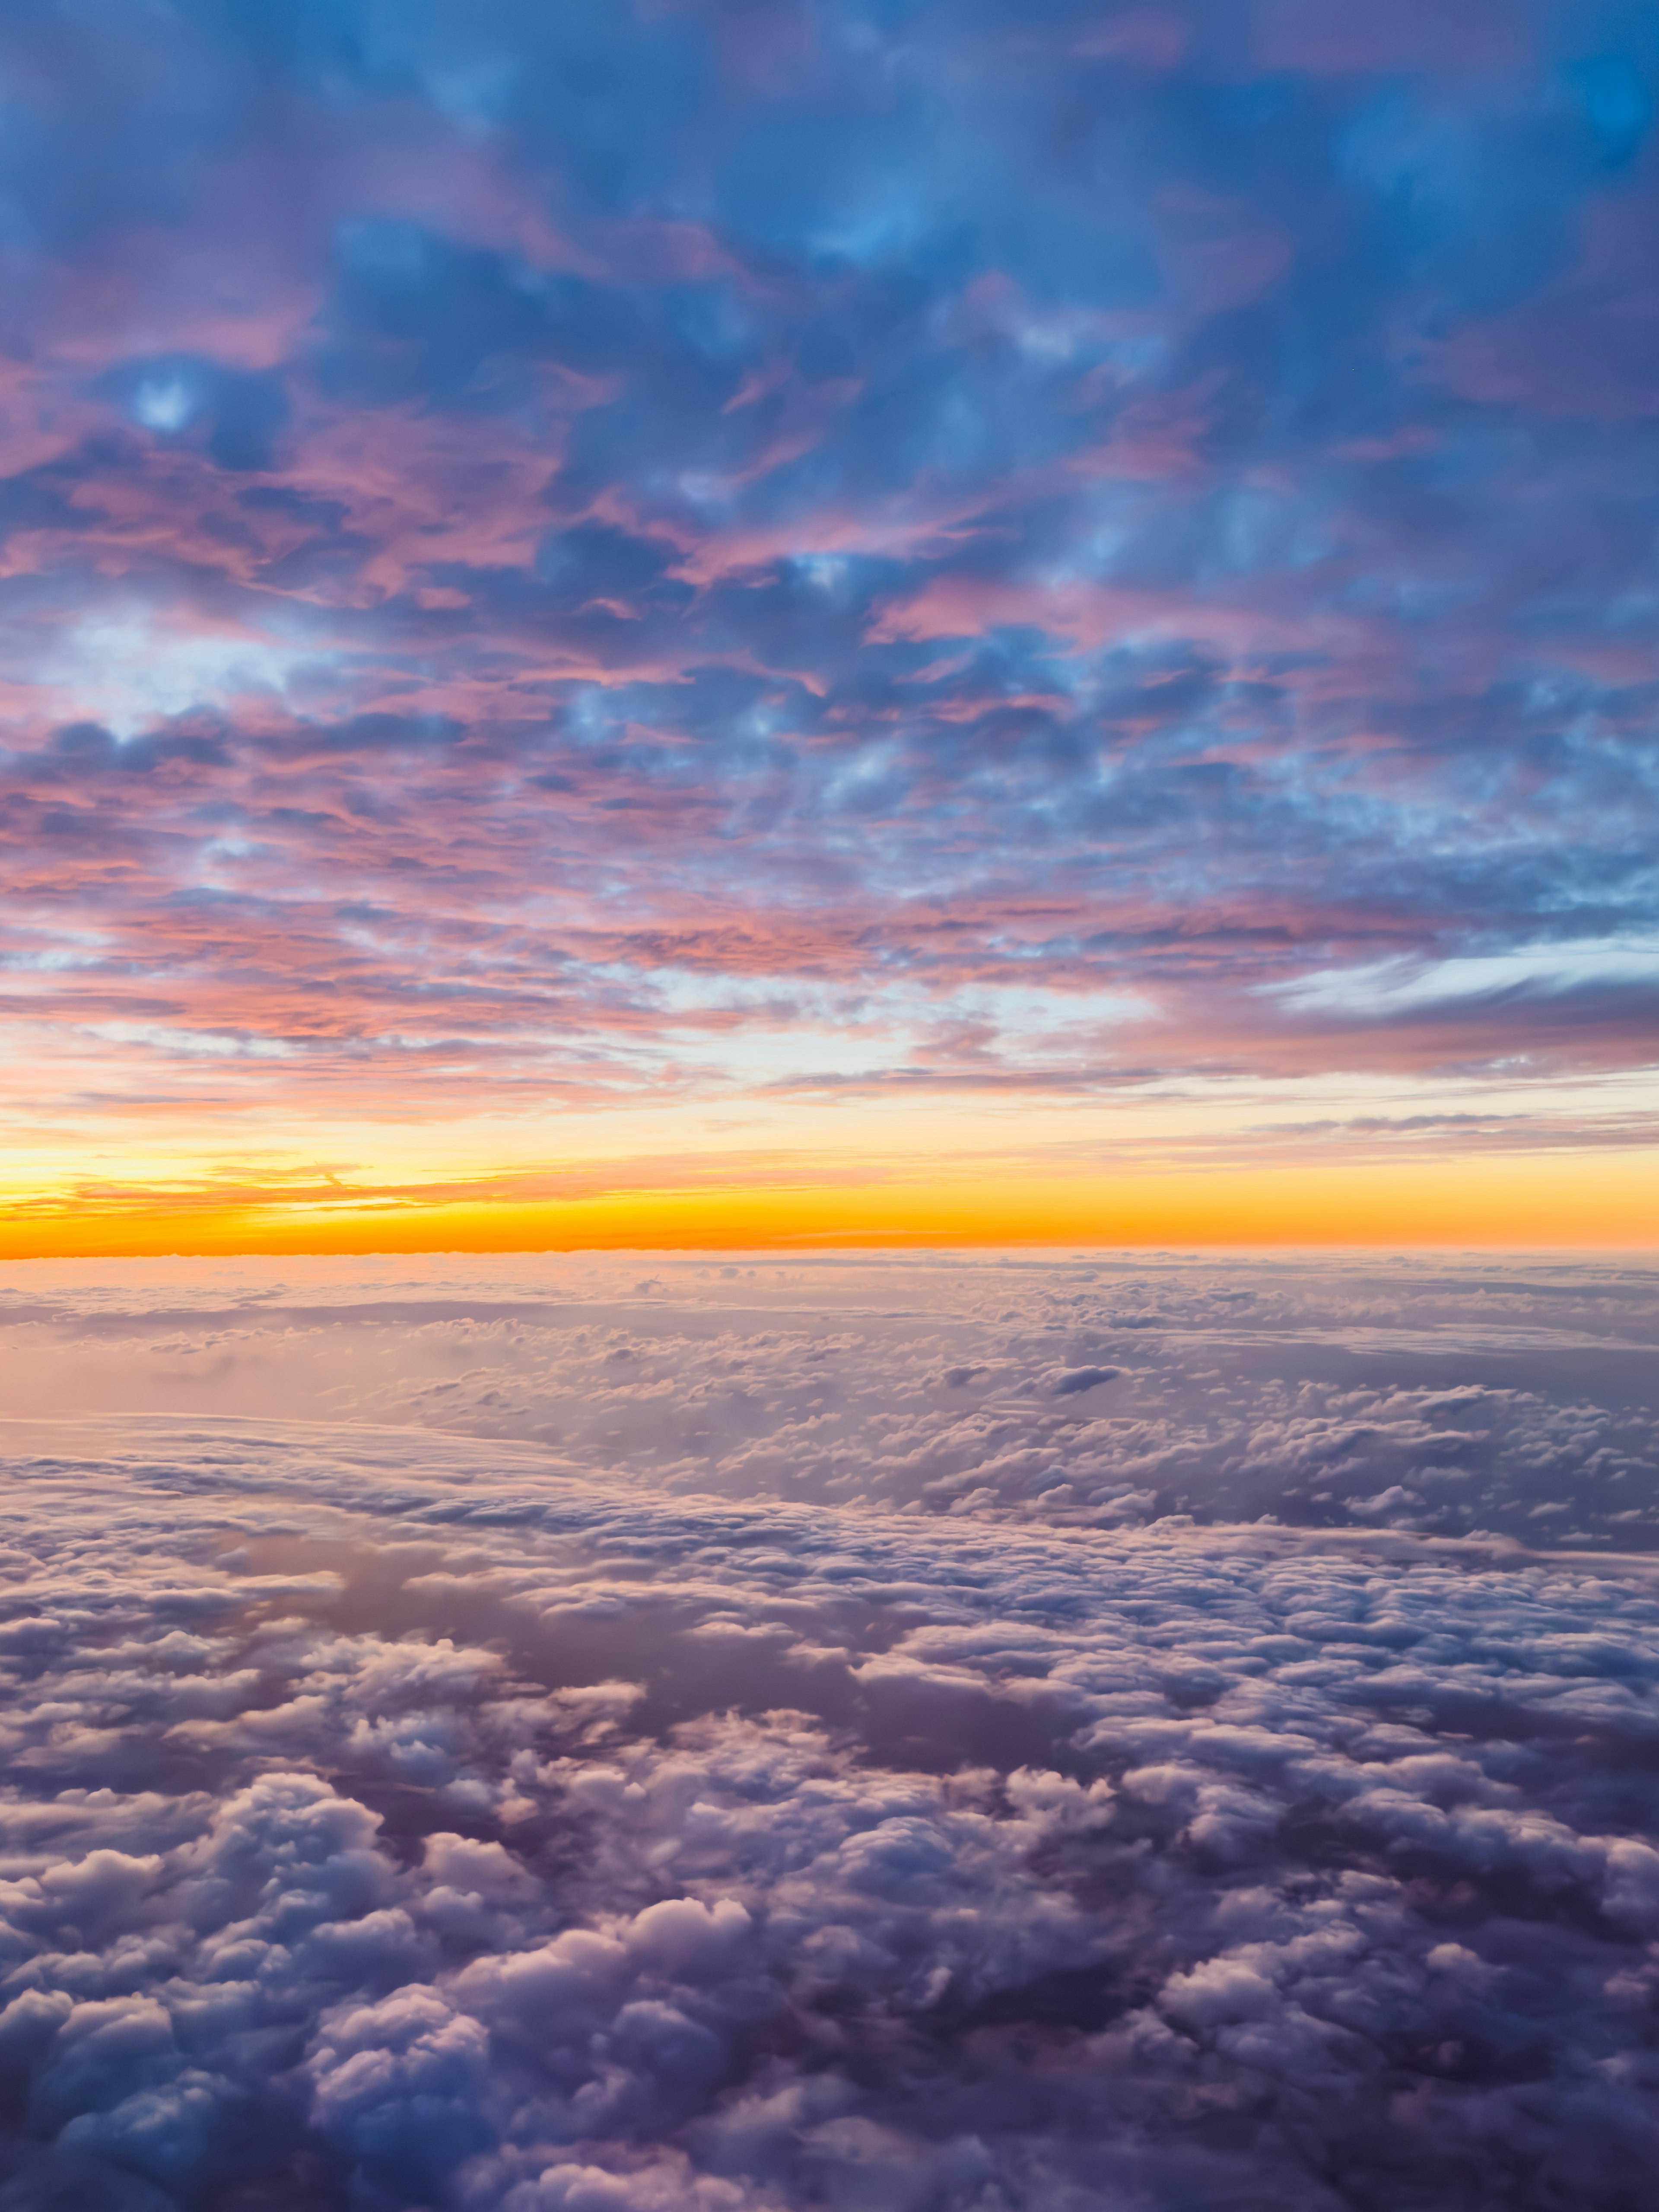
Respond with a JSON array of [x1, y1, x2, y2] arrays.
[[0, 0, 1659, 1256]]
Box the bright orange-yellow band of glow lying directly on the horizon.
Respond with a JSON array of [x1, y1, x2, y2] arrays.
[[0, 1150, 1659, 1261]]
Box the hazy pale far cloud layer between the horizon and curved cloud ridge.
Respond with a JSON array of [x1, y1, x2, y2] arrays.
[[0, 1254, 1659, 1551]]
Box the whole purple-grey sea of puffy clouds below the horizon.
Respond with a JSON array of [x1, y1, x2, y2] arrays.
[[0, 1259, 1659, 2212]]
